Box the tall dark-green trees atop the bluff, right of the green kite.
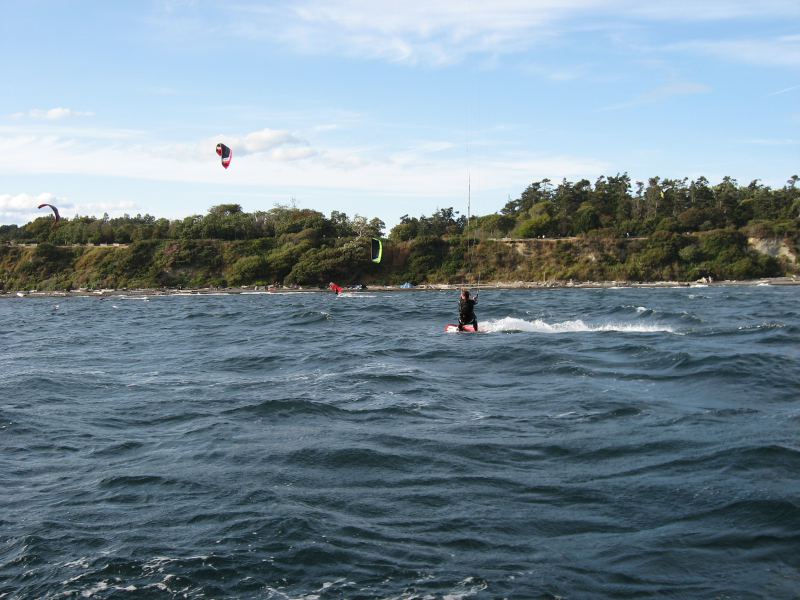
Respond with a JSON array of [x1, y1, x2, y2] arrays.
[[389, 174, 800, 240]]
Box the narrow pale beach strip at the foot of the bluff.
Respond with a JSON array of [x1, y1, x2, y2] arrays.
[[0, 276, 800, 299]]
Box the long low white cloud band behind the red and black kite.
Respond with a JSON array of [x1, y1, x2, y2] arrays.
[[0, 125, 605, 214]]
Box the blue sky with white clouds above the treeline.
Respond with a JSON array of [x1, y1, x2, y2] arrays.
[[0, 0, 800, 229]]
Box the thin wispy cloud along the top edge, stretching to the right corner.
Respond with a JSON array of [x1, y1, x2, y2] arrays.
[[216, 0, 800, 66]]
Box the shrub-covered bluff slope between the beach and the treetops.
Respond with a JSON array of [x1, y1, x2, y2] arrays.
[[0, 229, 800, 291]]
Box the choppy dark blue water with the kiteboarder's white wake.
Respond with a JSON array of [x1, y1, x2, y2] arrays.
[[0, 286, 800, 600]]
